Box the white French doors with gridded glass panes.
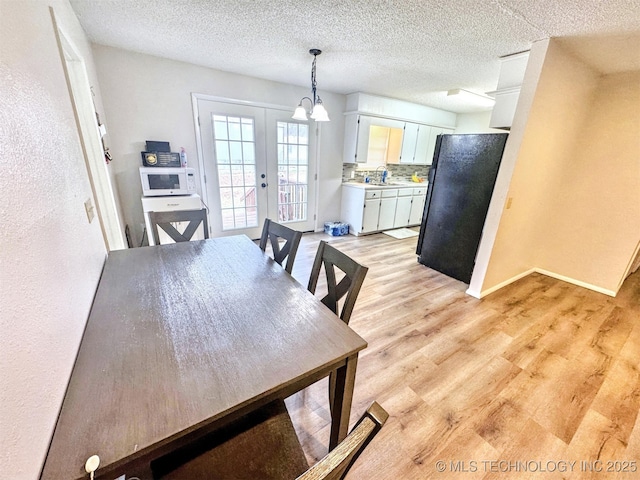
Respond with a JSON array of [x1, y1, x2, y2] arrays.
[[195, 97, 316, 238]]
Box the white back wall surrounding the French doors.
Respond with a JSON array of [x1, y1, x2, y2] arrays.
[[93, 45, 345, 244]]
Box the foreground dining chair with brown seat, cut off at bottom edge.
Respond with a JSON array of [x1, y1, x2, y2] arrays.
[[151, 400, 389, 480]]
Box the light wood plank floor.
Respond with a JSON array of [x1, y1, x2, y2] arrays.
[[287, 234, 640, 480]]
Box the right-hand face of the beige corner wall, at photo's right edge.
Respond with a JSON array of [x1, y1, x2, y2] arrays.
[[536, 72, 640, 292]]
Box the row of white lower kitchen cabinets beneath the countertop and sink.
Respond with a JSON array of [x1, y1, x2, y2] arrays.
[[340, 184, 426, 235]]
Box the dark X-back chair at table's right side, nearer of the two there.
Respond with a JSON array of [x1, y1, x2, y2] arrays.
[[307, 240, 369, 324]]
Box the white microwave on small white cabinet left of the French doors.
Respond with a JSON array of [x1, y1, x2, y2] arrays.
[[140, 167, 196, 197]]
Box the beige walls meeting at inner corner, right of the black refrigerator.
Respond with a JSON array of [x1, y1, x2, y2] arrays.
[[482, 40, 640, 294]]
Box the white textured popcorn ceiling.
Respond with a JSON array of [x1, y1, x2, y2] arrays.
[[70, 0, 640, 112]]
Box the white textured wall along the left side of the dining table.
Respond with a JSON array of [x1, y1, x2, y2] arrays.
[[0, 0, 106, 480]]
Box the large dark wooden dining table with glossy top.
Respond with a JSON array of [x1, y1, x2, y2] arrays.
[[41, 235, 367, 480]]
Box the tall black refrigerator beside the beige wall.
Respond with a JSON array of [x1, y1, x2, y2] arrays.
[[416, 133, 508, 283]]
